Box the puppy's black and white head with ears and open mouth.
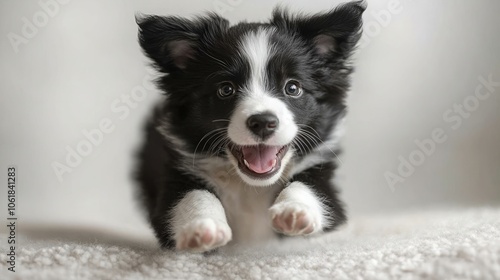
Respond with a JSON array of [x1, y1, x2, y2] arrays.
[[138, 2, 365, 186]]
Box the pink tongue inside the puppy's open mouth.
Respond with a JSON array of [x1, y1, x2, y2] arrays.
[[242, 145, 280, 174]]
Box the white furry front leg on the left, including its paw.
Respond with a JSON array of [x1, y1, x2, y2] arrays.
[[171, 190, 232, 252]]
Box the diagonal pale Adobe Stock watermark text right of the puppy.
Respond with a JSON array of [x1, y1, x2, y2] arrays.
[[384, 74, 500, 192]]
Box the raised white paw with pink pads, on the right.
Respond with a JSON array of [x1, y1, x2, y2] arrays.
[[269, 202, 322, 235]]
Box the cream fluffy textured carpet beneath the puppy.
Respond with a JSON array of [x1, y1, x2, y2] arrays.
[[0, 208, 500, 280]]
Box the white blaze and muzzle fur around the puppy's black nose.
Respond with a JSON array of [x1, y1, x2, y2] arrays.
[[228, 28, 298, 146]]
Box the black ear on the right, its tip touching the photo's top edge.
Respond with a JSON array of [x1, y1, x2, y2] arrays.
[[271, 1, 366, 57]]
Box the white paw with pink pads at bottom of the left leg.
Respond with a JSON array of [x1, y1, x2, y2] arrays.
[[175, 218, 232, 252]]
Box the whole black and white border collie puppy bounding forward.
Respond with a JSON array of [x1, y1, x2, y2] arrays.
[[137, 1, 365, 252]]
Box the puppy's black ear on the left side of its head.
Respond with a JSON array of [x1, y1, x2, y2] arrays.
[[136, 14, 229, 73]]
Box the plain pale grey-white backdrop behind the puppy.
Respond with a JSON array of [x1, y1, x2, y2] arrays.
[[0, 0, 500, 233]]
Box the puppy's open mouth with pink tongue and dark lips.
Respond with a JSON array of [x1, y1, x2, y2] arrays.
[[229, 144, 288, 179]]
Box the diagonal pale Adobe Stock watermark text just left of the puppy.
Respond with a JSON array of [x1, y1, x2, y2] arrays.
[[51, 69, 156, 183]]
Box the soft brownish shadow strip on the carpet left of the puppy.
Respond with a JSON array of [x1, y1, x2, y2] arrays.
[[18, 225, 160, 252]]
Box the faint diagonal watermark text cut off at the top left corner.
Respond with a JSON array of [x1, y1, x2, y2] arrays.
[[7, 0, 71, 53]]
